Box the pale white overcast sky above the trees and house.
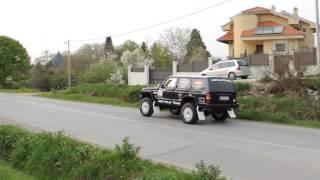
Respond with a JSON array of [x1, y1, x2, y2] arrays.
[[0, 0, 315, 58]]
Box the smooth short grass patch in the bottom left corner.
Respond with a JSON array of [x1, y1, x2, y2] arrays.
[[0, 161, 36, 180]]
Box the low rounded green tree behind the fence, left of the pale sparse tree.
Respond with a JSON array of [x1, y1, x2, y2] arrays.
[[151, 43, 172, 67]]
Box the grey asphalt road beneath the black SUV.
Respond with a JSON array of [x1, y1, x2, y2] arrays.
[[0, 93, 320, 180]]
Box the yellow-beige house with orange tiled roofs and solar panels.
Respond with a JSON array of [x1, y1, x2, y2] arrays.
[[218, 7, 316, 58]]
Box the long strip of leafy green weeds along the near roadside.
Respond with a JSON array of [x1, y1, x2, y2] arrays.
[[0, 126, 195, 180]]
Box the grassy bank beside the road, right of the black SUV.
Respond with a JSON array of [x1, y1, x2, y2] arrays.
[[236, 94, 320, 128]]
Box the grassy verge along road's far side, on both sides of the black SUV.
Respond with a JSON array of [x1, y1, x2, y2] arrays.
[[39, 83, 320, 128]]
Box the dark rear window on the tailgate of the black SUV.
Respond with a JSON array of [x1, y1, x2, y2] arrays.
[[209, 78, 236, 92]]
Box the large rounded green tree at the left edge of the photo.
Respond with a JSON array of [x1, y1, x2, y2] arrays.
[[0, 36, 31, 86]]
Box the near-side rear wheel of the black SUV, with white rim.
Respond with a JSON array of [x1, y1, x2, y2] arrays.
[[181, 103, 198, 124]]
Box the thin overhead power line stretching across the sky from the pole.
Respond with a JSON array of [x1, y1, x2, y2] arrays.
[[70, 0, 232, 43]]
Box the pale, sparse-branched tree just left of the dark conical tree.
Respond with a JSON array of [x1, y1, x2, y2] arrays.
[[160, 28, 191, 63]]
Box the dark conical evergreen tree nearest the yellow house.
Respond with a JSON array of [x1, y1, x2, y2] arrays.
[[186, 29, 210, 63]]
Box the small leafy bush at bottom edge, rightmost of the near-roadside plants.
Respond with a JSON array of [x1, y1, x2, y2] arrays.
[[195, 161, 226, 180]]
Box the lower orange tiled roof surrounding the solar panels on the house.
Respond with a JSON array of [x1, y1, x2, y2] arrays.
[[241, 21, 304, 37]]
